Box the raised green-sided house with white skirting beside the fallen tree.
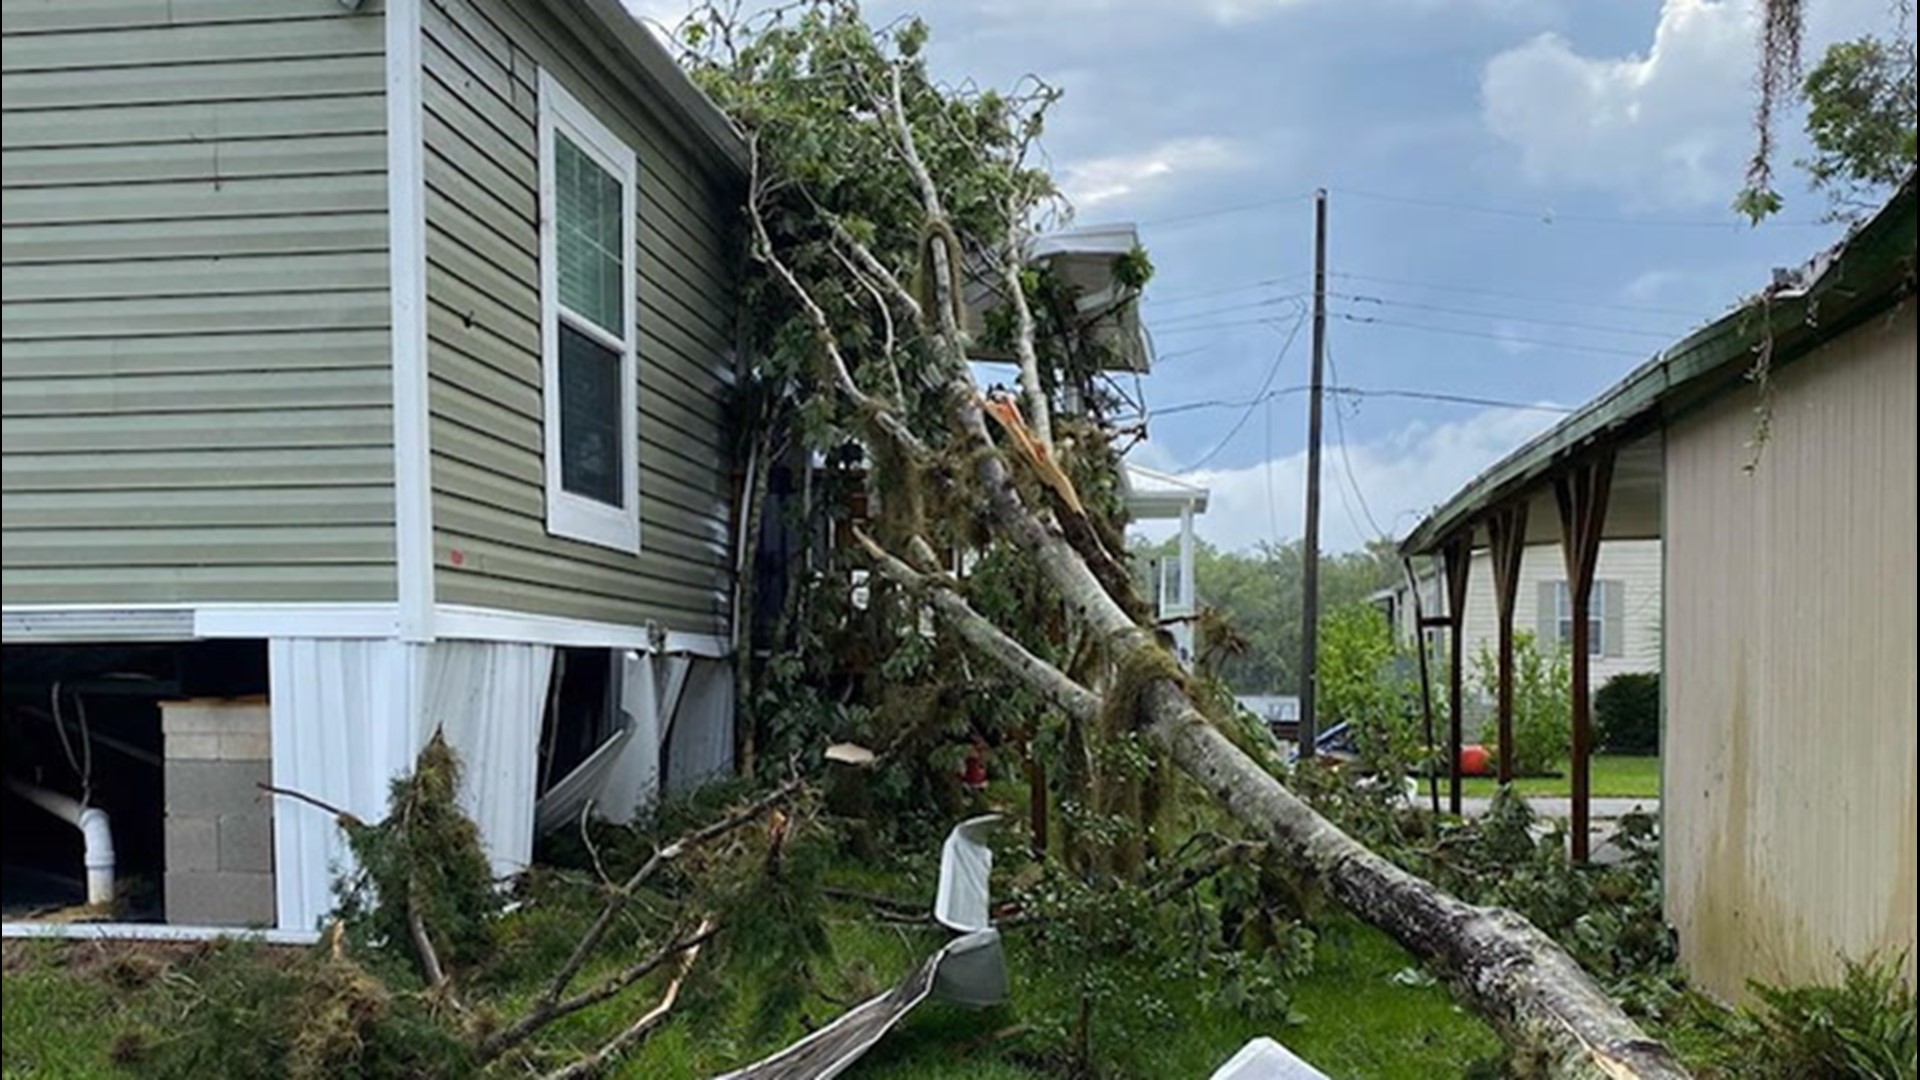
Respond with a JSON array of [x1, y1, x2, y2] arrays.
[[0, 0, 743, 934]]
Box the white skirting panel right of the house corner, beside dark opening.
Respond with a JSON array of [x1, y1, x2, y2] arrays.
[[420, 642, 553, 876]]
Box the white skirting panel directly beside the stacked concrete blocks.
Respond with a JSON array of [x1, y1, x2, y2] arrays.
[[269, 638, 420, 930]]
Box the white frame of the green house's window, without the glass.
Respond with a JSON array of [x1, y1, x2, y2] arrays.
[[540, 69, 639, 553]]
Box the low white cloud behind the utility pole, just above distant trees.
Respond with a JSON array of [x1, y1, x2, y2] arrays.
[[1133, 404, 1559, 552]]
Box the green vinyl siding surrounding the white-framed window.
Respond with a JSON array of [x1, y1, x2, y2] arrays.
[[422, 0, 733, 632]]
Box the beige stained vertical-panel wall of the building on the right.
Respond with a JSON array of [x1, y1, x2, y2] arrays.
[[1663, 300, 1916, 999]]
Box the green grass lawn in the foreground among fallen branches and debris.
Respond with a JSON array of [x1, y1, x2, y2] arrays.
[[0, 880, 1501, 1080]]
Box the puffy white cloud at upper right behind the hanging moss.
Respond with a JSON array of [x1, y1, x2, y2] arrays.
[[1480, 0, 1885, 208]]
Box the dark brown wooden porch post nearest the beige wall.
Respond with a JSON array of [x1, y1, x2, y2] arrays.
[[1553, 452, 1613, 863]]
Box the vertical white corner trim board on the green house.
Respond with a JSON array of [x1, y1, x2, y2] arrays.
[[384, 0, 434, 642]]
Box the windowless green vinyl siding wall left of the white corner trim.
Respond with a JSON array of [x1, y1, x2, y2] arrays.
[[0, 0, 396, 603]]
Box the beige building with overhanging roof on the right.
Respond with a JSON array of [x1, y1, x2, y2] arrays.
[[1404, 177, 1920, 999]]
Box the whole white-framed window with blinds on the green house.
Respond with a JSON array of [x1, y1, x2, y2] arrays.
[[540, 71, 639, 552]]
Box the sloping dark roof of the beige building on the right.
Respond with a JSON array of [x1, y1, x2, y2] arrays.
[[1400, 173, 1914, 555]]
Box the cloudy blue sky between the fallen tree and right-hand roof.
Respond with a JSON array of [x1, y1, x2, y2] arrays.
[[630, 0, 1891, 552]]
